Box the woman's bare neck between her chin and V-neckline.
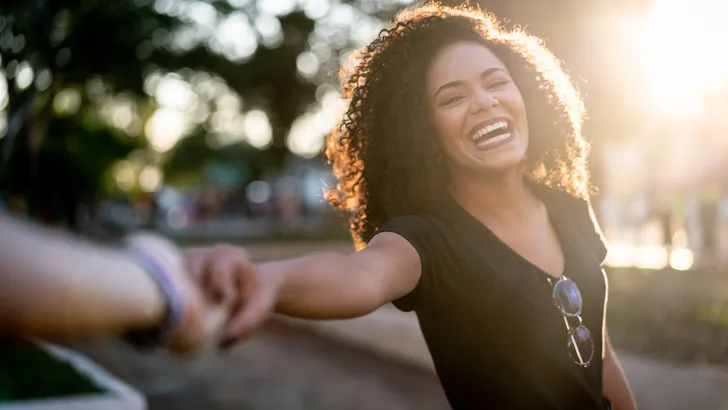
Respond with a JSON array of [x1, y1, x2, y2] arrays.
[[450, 170, 536, 222]]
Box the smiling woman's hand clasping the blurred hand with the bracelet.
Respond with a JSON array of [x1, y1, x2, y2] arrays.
[[184, 245, 279, 348]]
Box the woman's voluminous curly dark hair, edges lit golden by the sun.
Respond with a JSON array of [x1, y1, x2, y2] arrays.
[[325, 4, 589, 249]]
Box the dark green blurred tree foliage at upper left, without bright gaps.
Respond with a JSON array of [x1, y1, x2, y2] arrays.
[[0, 0, 356, 221]]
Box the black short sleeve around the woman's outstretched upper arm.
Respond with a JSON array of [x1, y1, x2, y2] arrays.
[[374, 215, 437, 312]]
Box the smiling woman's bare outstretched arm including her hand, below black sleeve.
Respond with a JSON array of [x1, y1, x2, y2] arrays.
[[186, 232, 422, 344]]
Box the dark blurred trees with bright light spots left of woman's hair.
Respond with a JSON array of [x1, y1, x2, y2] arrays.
[[0, 0, 408, 227]]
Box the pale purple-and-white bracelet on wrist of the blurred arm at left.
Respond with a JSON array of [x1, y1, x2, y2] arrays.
[[124, 234, 192, 349]]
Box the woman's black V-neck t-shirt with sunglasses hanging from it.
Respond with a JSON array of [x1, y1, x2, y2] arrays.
[[378, 184, 607, 410]]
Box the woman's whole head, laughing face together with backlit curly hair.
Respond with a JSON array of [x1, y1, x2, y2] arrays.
[[326, 4, 590, 246]]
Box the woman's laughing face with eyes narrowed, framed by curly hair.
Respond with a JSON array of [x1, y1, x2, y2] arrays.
[[426, 42, 529, 173]]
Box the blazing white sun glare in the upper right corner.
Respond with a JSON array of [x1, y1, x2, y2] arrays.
[[645, 0, 728, 118]]
